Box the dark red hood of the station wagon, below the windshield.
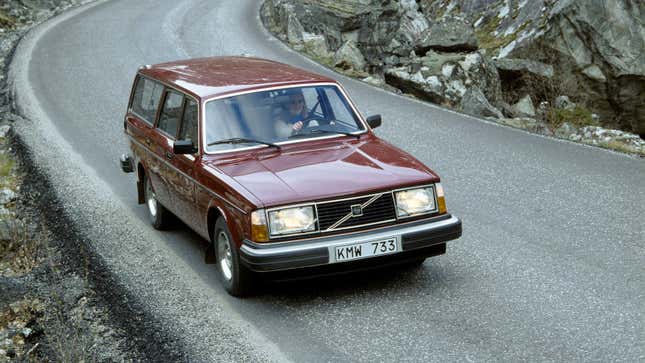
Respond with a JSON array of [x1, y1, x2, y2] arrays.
[[209, 136, 439, 207]]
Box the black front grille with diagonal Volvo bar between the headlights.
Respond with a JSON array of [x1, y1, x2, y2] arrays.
[[317, 192, 396, 232]]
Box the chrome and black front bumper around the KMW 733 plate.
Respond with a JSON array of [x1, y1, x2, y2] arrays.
[[240, 215, 461, 272]]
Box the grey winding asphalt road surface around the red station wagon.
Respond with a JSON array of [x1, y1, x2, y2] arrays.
[[12, 0, 645, 362]]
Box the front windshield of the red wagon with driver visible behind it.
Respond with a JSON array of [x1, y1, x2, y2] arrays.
[[204, 85, 365, 152]]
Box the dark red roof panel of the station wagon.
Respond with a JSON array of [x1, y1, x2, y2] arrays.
[[139, 57, 336, 99]]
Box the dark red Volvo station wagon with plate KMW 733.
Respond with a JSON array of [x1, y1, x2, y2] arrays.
[[121, 57, 461, 296]]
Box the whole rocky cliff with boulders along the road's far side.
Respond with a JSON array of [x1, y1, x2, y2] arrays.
[[262, 0, 645, 145]]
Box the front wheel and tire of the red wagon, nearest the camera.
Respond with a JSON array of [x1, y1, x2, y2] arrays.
[[213, 218, 253, 297]]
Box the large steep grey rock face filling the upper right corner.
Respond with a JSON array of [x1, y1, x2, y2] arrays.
[[542, 0, 645, 133]]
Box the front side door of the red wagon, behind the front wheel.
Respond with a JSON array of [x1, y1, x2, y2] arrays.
[[170, 96, 200, 229]]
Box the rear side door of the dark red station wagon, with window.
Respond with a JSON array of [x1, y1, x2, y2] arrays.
[[150, 87, 184, 214]]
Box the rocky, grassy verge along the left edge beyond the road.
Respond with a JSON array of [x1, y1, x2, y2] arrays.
[[0, 0, 142, 362]]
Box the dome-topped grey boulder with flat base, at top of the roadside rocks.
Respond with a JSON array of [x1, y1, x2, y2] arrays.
[[414, 18, 478, 54]]
